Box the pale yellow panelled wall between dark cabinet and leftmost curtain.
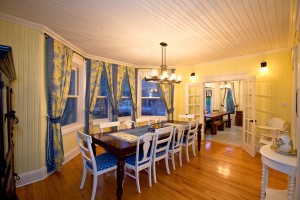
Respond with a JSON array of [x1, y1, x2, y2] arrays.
[[0, 20, 46, 174]]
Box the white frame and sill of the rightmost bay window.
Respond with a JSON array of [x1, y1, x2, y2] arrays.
[[137, 69, 168, 119]]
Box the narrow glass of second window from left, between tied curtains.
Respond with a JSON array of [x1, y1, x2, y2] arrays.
[[93, 70, 108, 119]]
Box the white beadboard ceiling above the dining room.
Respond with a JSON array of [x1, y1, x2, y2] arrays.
[[0, 0, 297, 67]]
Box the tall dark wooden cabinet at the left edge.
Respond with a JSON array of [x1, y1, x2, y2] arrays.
[[0, 45, 18, 200]]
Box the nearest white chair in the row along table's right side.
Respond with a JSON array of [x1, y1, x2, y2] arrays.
[[125, 133, 154, 193]]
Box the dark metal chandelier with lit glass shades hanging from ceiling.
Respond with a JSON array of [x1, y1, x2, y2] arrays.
[[144, 42, 181, 85]]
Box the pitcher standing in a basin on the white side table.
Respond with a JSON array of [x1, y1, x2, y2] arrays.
[[271, 131, 297, 155]]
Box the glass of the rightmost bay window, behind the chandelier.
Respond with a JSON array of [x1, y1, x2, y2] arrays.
[[139, 80, 166, 116]]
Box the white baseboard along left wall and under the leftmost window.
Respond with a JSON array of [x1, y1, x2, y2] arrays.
[[16, 146, 80, 188]]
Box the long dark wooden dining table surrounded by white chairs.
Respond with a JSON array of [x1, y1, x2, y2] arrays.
[[91, 120, 202, 200]]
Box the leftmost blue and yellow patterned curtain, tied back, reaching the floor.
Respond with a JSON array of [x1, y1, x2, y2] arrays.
[[46, 37, 73, 173]]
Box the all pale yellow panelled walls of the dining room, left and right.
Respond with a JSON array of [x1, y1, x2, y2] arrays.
[[0, 20, 292, 173]]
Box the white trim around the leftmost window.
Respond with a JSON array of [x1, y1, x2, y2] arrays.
[[61, 54, 86, 135]]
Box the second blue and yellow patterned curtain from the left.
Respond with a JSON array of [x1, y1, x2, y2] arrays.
[[85, 59, 103, 134]]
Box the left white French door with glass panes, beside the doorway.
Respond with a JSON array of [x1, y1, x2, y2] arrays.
[[185, 83, 201, 120]]
